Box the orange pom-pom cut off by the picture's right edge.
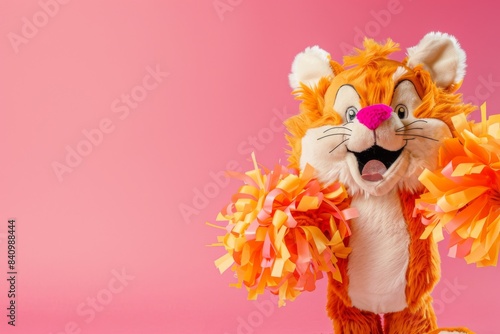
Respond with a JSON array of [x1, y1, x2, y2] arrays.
[[416, 104, 500, 267]]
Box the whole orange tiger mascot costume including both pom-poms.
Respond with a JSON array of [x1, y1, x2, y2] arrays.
[[214, 33, 500, 334]]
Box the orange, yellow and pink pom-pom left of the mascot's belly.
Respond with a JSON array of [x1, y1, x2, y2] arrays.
[[208, 155, 357, 306]]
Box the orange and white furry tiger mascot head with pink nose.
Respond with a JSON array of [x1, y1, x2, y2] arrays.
[[286, 33, 473, 196]]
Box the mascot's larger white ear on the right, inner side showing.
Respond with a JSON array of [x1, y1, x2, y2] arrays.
[[407, 32, 466, 89]]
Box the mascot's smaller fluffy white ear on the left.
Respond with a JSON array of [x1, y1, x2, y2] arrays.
[[288, 46, 340, 90]]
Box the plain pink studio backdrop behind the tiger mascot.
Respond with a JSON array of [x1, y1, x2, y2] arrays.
[[0, 0, 500, 334]]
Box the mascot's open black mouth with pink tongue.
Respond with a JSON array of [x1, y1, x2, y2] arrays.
[[349, 145, 404, 181]]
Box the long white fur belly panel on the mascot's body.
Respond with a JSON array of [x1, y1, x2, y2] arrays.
[[347, 190, 410, 313]]
